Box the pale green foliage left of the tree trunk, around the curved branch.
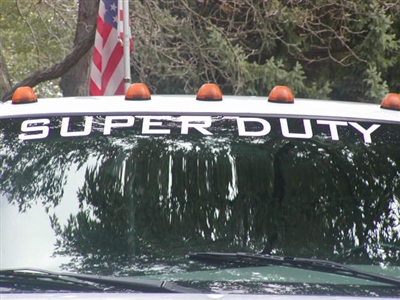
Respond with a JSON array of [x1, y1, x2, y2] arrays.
[[0, 0, 77, 97]]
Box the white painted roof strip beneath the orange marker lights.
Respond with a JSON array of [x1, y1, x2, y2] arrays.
[[0, 95, 400, 123]]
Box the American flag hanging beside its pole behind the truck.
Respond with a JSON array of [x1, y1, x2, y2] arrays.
[[89, 0, 132, 96]]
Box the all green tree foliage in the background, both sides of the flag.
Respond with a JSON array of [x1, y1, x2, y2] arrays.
[[0, 0, 400, 102]]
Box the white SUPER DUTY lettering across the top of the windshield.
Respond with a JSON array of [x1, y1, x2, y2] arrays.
[[18, 116, 381, 143]]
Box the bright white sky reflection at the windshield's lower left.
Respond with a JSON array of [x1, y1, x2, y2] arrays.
[[0, 166, 84, 271]]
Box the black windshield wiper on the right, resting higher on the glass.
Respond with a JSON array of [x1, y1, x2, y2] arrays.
[[189, 252, 400, 287]]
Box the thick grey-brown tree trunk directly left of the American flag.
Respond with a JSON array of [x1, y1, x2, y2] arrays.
[[60, 0, 99, 97]]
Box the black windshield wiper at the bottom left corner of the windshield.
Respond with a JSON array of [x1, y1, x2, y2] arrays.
[[0, 269, 200, 293]]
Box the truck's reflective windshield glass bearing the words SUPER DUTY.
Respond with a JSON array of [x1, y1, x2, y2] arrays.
[[0, 116, 400, 295]]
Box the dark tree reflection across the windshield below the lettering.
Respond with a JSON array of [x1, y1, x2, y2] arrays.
[[0, 118, 400, 275]]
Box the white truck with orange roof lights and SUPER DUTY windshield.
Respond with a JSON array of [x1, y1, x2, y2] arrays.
[[0, 84, 400, 299]]
